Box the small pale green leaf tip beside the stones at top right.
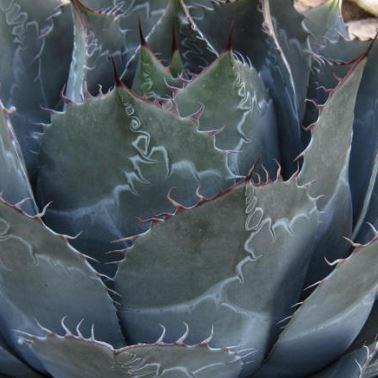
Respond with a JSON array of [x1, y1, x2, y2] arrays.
[[304, 0, 349, 43]]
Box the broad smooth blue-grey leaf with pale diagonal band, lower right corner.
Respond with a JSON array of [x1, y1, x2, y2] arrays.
[[257, 235, 378, 378]]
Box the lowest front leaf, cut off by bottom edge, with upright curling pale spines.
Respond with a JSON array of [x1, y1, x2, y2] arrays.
[[24, 329, 241, 378]]
